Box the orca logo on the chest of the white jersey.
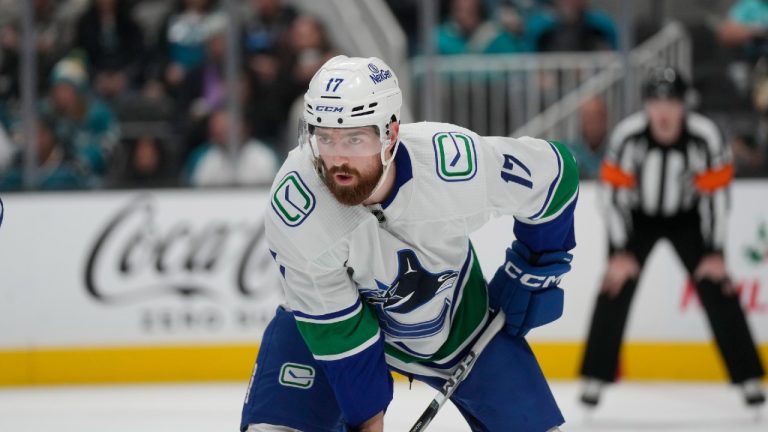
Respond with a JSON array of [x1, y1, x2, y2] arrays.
[[360, 249, 459, 337]]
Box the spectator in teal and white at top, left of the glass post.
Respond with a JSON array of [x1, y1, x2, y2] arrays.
[[145, 0, 216, 97]]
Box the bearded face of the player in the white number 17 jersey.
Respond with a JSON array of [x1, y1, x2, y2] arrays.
[[313, 127, 383, 206]]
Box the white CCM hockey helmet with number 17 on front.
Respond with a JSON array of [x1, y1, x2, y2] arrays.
[[300, 55, 403, 159]]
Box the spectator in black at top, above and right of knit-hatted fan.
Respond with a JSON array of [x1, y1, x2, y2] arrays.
[[76, 0, 143, 99]]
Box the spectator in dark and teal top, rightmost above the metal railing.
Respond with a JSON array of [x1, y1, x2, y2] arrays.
[[528, 0, 619, 52]]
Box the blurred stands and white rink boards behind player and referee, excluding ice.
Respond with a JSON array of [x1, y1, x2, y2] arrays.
[[0, 0, 768, 430]]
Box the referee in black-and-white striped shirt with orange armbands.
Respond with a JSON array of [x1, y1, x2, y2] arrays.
[[581, 68, 765, 406]]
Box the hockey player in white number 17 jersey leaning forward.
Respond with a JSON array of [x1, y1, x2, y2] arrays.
[[241, 56, 578, 432]]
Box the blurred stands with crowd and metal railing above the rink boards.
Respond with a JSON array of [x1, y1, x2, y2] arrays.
[[0, 0, 768, 191]]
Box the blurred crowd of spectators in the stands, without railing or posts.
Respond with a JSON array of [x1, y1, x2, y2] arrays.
[[0, 0, 768, 190]]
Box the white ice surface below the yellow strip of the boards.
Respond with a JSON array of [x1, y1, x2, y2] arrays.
[[0, 382, 768, 432]]
